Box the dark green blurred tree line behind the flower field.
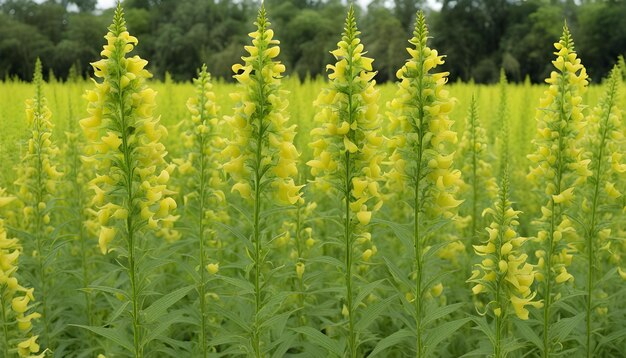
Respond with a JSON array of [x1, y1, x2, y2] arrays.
[[0, 0, 626, 83]]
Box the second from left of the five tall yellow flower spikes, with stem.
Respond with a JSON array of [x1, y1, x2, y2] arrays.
[[220, 6, 302, 354]]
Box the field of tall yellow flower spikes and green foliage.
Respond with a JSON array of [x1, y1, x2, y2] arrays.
[[0, 6, 626, 358]]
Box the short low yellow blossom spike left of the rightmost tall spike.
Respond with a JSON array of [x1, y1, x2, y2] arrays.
[[468, 178, 543, 320]]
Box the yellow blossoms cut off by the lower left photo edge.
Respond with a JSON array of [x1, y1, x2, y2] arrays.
[[0, 188, 43, 357]]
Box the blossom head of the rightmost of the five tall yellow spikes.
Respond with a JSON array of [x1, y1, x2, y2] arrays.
[[527, 26, 592, 292]]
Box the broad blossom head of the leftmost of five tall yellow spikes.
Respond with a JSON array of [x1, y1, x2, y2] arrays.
[[80, 6, 177, 253]]
